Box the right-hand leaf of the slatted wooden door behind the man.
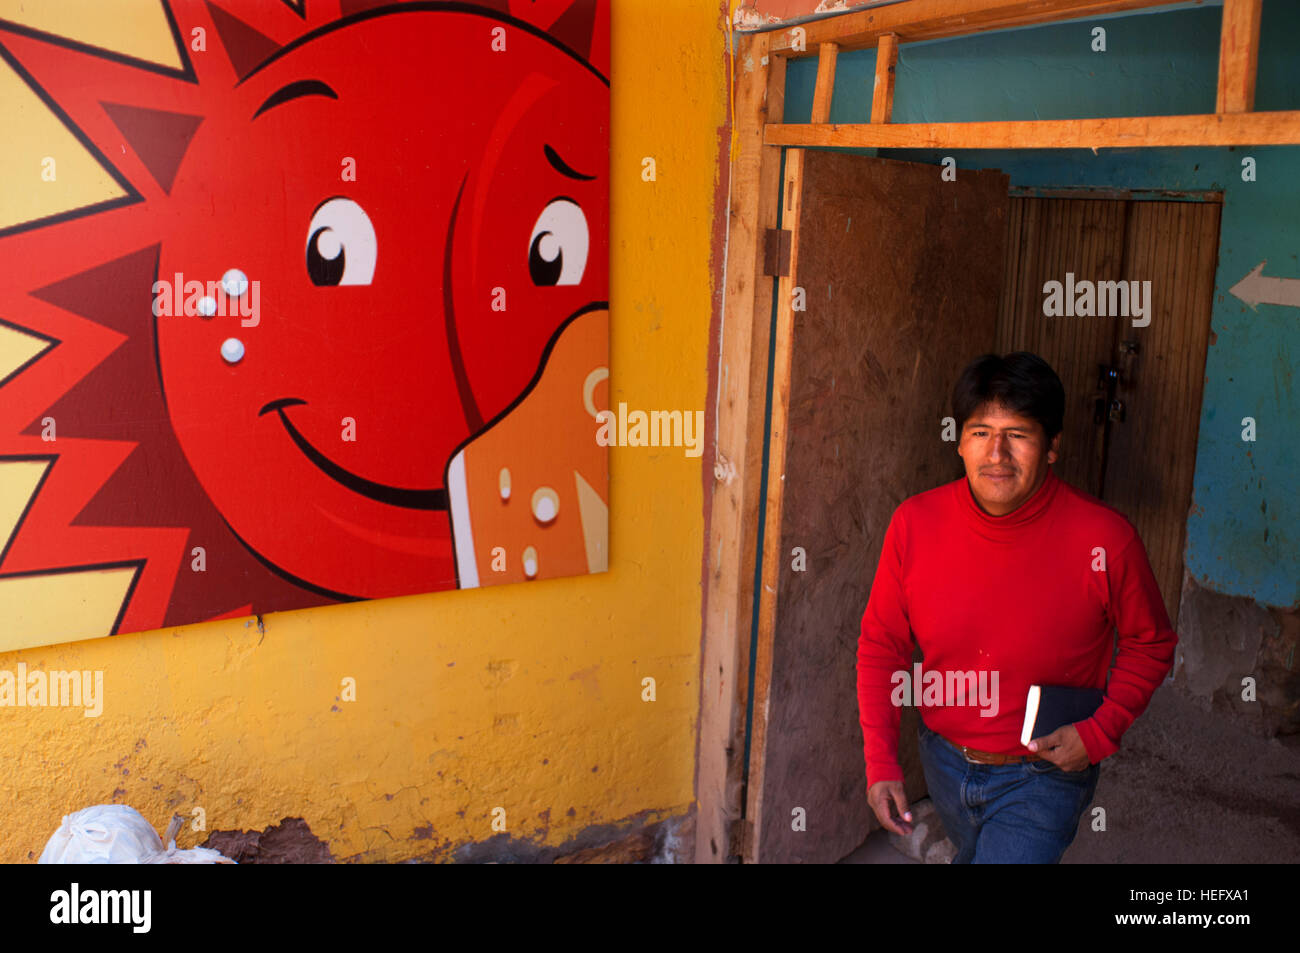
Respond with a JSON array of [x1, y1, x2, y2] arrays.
[[1105, 202, 1221, 627]]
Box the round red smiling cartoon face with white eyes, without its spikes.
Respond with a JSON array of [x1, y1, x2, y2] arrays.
[[155, 8, 608, 597]]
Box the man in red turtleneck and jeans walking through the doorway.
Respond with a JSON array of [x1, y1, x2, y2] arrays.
[[858, 352, 1177, 863]]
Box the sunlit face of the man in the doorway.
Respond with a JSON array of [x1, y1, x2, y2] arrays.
[[957, 404, 1061, 516]]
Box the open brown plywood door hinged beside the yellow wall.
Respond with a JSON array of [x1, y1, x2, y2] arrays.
[[748, 152, 1009, 862]]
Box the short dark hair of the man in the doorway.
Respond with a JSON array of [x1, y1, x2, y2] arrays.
[[953, 351, 1065, 443]]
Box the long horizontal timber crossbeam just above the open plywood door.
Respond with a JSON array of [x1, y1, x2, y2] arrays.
[[763, 111, 1300, 150]]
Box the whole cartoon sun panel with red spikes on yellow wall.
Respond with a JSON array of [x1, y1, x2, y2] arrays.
[[0, 0, 610, 649]]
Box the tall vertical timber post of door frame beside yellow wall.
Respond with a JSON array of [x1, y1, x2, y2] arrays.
[[696, 34, 785, 863]]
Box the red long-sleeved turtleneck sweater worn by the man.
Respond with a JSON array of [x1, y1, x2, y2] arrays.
[[858, 468, 1178, 785]]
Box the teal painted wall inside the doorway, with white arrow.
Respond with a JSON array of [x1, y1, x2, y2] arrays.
[[785, 0, 1300, 608]]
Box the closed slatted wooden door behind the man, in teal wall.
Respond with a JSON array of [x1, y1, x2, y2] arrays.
[[997, 198, 1219, 624]]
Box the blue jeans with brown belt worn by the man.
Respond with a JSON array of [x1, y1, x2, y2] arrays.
[[919, 722, 1101, 863]]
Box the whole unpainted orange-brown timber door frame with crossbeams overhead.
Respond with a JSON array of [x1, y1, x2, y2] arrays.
[[696, 0, 1284, 863]]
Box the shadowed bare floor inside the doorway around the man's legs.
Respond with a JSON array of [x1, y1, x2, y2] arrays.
[[840, 685, 1300, 863]]
